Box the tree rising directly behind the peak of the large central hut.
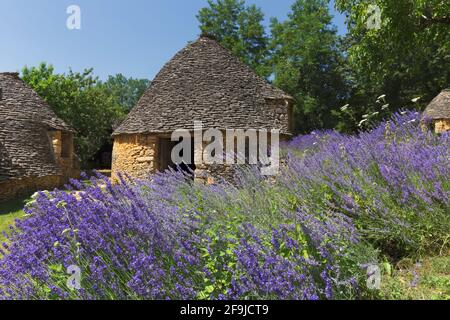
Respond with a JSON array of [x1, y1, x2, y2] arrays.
[[197, 0, 270, 77]]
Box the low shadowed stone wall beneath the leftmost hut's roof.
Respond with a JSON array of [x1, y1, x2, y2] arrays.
[[0, 176, 62, 202]]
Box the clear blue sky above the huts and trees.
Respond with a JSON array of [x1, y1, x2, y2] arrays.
[[0, 0, 346, 79]]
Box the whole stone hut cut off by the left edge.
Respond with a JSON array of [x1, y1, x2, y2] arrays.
[[0, 73, 79, 201]]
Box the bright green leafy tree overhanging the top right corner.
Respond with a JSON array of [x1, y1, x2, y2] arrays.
[[336, 0, 450, 111]]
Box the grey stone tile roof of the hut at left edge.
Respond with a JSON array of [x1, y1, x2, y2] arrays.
[[0, 73, 72, 182]]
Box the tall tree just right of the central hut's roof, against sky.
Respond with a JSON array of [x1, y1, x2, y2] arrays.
[[271, 0, 346, 133]]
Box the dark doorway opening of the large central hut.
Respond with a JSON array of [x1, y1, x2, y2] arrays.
[[159, 138, 196, 175]]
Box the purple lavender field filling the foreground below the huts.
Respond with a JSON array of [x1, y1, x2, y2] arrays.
[[0, 112, 450, 300]]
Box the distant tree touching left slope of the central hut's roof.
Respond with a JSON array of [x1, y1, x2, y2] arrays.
[[103, 73, 150, 113]]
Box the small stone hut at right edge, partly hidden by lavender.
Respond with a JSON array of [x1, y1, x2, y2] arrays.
[[423, 89, 450, 133]]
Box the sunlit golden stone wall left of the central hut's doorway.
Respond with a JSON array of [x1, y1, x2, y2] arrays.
[[112, 134, 159, 182]]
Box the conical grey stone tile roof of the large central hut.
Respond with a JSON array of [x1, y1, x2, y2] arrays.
[[113, 37, 292, 135]]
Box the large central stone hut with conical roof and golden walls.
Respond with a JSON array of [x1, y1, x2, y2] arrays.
[[112, 36, 293, 180]]
